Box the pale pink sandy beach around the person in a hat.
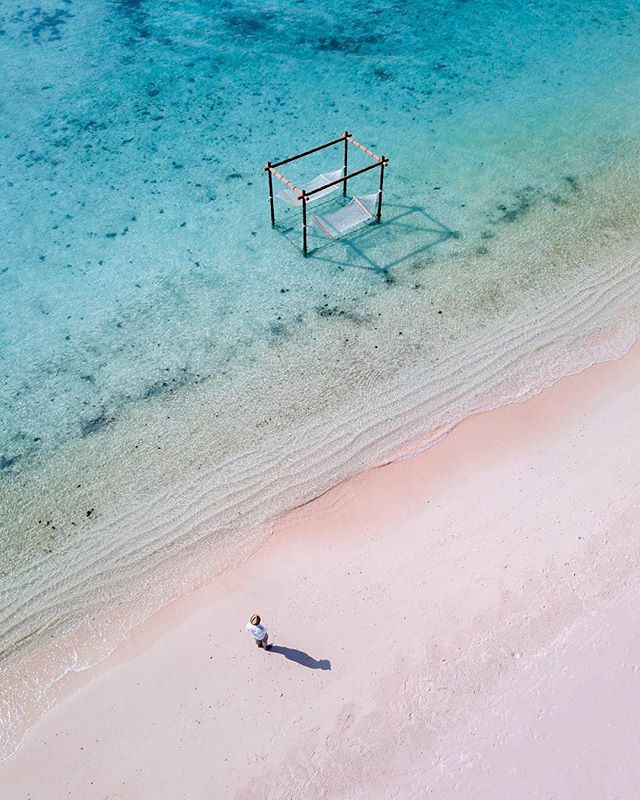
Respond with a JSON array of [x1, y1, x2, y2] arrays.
[[0, 347, 640, 800]]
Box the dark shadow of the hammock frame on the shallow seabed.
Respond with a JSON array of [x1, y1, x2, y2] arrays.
[[277, 202, 460, 277]]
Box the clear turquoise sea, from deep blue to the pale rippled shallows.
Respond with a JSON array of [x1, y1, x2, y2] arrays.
[[0, 0, 640, 756]]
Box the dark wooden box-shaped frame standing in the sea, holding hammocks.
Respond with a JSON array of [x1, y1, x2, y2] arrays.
[[264, 131, 389, 256]]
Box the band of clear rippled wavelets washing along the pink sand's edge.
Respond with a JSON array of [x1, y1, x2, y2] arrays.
[[0, 230, 640, 756]]
